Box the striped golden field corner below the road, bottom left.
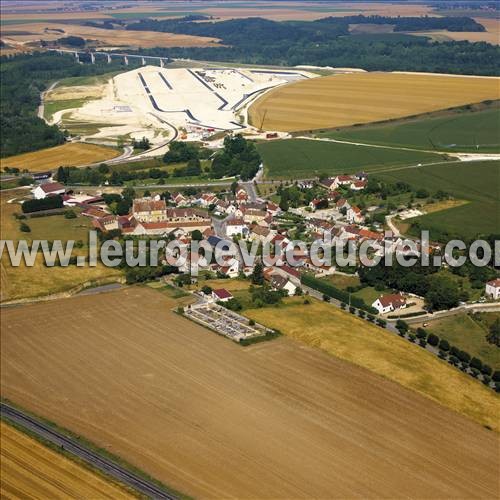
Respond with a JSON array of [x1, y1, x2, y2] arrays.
[[0, 422, 134, 499]]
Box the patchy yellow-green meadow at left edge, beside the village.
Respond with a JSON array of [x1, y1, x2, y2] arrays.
[[0, 189, 122, 302]]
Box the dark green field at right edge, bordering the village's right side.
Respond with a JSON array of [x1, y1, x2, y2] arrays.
[[377, 161, 500, 239]]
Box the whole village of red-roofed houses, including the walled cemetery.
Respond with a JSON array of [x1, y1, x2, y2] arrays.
[[24, 164, 500, 348]]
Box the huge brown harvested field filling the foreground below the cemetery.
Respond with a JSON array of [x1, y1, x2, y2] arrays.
[[1, 287, 499, 498]]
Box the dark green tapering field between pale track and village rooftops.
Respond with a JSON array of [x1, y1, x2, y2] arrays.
[[257, 139, 444, 179]]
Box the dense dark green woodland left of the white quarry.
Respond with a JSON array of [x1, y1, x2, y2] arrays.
[[0, 52, 135, 158]]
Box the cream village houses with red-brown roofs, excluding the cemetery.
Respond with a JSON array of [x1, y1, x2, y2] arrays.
[[27, 173, 500, 314]]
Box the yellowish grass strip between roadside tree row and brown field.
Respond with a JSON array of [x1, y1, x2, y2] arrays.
[[245, 298, 500, 431]]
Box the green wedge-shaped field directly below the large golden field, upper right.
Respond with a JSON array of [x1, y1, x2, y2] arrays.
[[320, 105, 500, 153]]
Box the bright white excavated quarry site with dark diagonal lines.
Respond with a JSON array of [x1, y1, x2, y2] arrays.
[[46, 66, 315, 148]]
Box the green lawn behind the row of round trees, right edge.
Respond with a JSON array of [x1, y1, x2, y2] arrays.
[[416, 313, 500, 370]]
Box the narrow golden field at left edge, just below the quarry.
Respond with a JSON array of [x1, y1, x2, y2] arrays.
[[0, 142, 120, 172]]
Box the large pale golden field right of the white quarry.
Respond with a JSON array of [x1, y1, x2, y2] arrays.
[[249, 73, 500, 132]]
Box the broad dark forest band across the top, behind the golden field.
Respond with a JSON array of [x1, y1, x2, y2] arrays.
[[122, 17, 500, 75]]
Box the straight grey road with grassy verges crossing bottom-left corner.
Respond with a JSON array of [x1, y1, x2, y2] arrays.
[[0, 403, 177, 500]]
